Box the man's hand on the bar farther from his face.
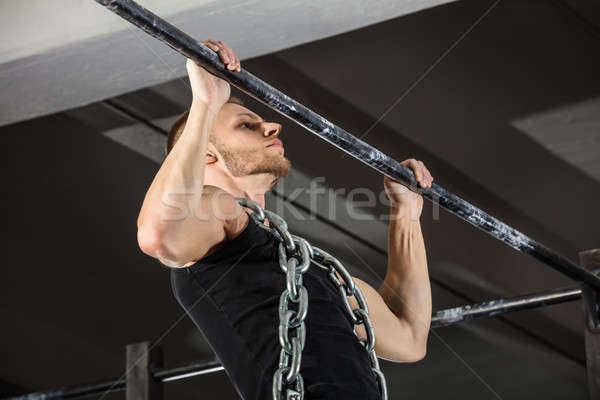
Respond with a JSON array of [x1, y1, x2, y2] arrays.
[[383, 158, 433, 220]]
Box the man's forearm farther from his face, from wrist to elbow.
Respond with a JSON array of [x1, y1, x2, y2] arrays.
[[379, 207, 431, 344]]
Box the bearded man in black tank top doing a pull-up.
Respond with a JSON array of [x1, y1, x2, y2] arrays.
[[138, 40, 433, 400]]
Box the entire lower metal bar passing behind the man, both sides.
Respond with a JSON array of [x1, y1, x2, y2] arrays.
[[2, 287, 581, 400]]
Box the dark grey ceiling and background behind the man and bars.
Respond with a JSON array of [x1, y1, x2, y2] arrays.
[[0, 0, 600, 400]]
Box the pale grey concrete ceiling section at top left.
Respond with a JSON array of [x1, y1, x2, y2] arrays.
[[0, 0, 451, 126]]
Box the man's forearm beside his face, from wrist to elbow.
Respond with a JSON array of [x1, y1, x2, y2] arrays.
[[138, 103, 218, 227]]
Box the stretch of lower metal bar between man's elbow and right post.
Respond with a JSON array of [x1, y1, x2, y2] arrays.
[[431, 286, 581, 328]]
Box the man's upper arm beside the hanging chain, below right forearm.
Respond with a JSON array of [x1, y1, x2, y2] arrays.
[[349, 277, 418, 362]]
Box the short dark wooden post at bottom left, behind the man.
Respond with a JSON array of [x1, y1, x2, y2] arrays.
[[125, 342, 163, 400]]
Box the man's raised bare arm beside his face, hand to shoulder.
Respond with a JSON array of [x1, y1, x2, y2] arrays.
[[137, 46, 239, 267]]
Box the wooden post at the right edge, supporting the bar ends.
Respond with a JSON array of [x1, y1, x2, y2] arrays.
[[579, 249, 600, 400]]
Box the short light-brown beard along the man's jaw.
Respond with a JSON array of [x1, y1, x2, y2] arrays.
[[217, 145, 291, 181]]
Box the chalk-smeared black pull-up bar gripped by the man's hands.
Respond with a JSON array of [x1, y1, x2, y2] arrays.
[[95, 0, 600, 289]]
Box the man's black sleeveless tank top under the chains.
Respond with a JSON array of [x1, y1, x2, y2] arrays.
[[171, 214, 381, 400]]
